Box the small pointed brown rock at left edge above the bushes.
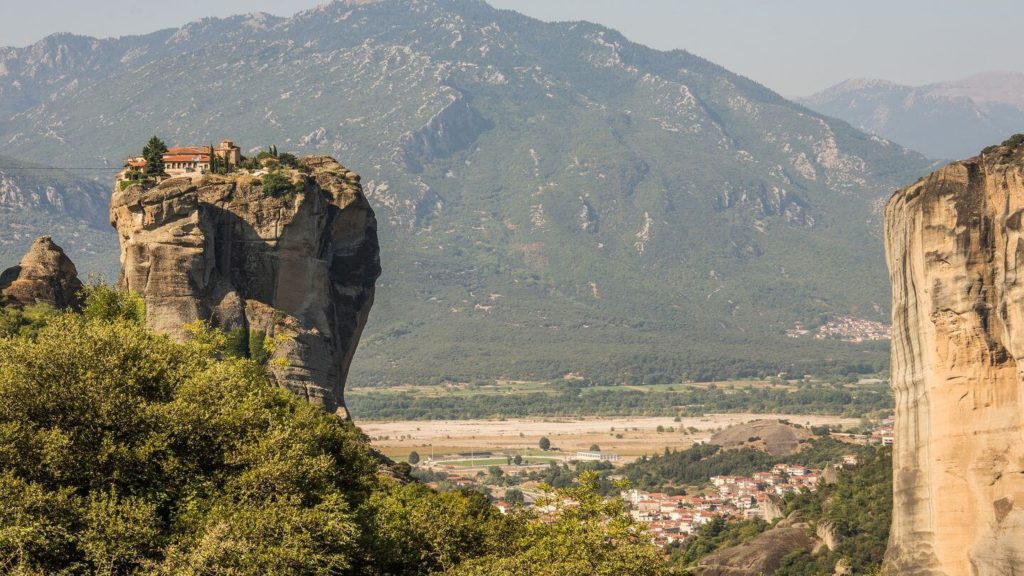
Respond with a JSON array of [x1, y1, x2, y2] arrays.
[[0, 236, 82, 308]]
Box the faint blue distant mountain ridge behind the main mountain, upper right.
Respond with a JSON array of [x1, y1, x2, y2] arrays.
[[799, 72, 1024, 159]]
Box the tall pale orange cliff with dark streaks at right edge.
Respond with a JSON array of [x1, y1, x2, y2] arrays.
[[885, 141, 1024, 576]]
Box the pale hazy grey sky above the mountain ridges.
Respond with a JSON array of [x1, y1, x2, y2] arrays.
[[0, 0, 1024, 95]]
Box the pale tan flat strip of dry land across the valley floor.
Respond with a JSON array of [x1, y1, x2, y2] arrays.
[[356, 414, 859, 459]]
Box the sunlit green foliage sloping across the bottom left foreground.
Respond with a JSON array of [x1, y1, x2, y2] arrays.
[[0, 293, 664, 576]]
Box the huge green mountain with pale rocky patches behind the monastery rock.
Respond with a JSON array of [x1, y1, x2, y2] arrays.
[[0, 0, 932, 386]]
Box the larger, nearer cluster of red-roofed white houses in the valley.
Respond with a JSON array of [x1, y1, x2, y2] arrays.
[[622, 454, 827, 545]]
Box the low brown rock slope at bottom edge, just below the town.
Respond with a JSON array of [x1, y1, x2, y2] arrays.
[[696, 515, 817, 576]]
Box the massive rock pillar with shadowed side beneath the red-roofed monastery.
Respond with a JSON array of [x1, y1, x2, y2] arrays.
[[111, 157, 380, 415]]
